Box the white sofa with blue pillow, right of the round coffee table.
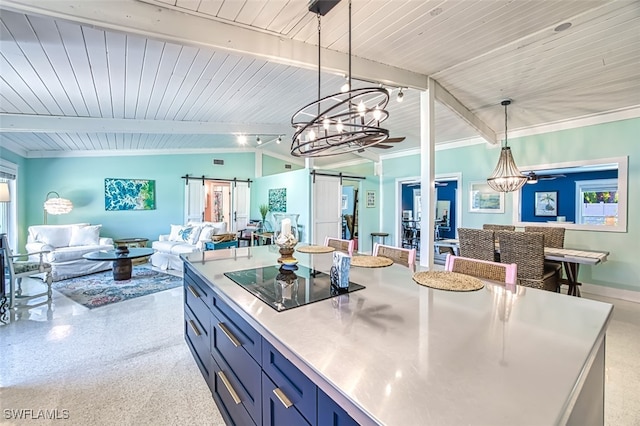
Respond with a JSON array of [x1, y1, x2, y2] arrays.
[[151, 222, 227, 271]]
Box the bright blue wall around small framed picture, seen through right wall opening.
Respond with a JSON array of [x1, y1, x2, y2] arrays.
[[521, 170, 618, 222]]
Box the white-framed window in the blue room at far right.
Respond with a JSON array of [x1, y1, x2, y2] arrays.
[[576, 179, 618, 226]]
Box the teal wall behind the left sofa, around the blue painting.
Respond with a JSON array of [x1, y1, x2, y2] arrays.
[[3, 151, 255, 248]]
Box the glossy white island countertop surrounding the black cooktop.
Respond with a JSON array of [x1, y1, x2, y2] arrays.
[[182, 246, 613, 426]]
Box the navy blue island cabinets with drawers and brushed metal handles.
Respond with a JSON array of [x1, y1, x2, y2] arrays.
[[184, 263, 357, 426]]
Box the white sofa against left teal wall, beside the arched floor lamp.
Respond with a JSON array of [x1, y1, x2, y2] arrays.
[[25, 223, 113, 281]]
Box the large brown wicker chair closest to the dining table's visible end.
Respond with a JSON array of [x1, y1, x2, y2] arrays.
[[498, 231, 561, 292]]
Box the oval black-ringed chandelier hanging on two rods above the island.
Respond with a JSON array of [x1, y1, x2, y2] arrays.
[[291, 0, 389, 157]]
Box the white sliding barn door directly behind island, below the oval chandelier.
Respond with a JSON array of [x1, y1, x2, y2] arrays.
[[312, 176, 342, 244]]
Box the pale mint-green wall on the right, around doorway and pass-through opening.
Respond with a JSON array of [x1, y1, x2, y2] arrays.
[[381, 119, 640, 291]]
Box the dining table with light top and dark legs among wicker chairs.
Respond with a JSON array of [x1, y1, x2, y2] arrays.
[[434, 238, 609, 297]]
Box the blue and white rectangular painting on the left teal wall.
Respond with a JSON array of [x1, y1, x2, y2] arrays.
[[104, 178, 156, 211]]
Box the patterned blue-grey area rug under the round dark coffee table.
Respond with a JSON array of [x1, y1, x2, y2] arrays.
[[52, 265, 182, 309]]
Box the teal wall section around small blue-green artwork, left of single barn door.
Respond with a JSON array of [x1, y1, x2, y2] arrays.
[[250, 169, 311, 242]]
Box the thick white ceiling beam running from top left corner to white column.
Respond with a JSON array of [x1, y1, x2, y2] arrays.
[[2, 0, 427, 90]]
